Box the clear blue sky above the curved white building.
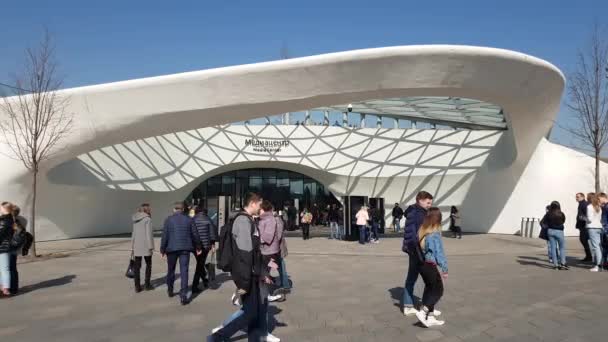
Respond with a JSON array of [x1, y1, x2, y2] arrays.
[[0, 0, 608, 150]]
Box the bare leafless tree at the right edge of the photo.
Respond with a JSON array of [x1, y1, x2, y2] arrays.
[[565, 24, 608, 192]]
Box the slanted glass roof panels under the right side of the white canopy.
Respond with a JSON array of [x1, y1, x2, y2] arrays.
[[314, 96, 507, 129]]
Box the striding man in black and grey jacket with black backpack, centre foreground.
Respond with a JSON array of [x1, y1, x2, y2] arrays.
[[207, 193, 273, 342]]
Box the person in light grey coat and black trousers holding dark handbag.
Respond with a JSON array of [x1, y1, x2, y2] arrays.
[[131, 203, 154, 293]]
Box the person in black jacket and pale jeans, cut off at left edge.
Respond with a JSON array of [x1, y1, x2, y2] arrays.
[[0, 202, 15, 296]]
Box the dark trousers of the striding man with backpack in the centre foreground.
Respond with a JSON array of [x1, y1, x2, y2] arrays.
[[212, 279, 267, 342]]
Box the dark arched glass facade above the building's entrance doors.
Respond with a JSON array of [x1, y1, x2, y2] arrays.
[[187, 169, 338, 209]]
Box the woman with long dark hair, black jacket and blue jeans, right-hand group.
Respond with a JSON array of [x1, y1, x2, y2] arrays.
[[541, 201, 568, 270]]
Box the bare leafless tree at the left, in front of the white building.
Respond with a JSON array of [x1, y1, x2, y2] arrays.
[[0, 30, 74, 256]]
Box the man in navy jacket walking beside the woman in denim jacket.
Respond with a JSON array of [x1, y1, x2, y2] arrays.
[[401, 191, 433, 316]]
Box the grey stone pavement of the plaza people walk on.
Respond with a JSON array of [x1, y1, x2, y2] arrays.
[[0, 235, 608, 342]]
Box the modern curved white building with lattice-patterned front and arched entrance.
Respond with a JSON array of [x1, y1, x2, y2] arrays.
[[0, 45, 593, 239]]
